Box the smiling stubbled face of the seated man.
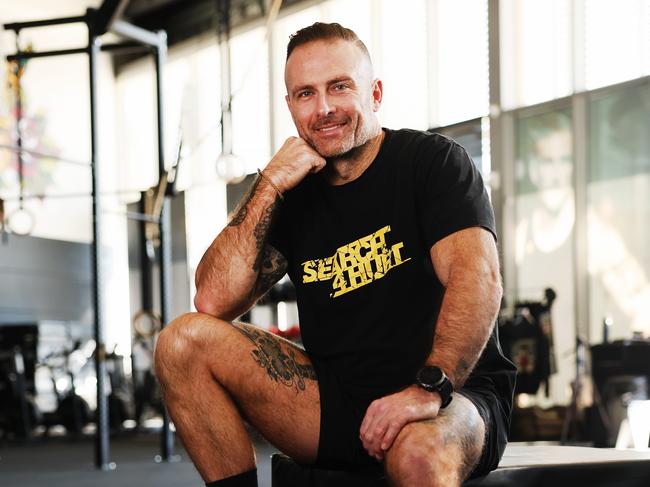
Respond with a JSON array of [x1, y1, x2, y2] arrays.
[[284, 40, 382, 158]]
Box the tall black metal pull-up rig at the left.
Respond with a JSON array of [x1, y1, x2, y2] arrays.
[[4, 0, 173, 470]]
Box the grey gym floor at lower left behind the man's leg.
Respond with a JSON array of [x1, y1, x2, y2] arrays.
[[0, 434, 277, 487]]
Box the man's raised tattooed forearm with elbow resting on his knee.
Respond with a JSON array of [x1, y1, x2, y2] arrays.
[[194, 178, 281, 320]]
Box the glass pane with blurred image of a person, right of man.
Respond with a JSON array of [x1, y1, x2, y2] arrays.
[[515, 109, 575, 401]]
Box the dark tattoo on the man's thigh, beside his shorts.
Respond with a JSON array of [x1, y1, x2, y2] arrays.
[[233, 323, 317, 393]]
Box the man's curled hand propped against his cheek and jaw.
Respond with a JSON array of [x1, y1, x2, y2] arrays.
[[264, 137, 325, 193]]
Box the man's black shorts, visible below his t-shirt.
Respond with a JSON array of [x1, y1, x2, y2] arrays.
[[312, 360, 509, 477]]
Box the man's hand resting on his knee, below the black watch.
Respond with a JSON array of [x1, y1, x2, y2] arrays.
[[359, 385, 442, 462]]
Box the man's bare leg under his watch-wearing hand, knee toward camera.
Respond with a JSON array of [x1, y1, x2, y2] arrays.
[[384, 394, 485, 487]]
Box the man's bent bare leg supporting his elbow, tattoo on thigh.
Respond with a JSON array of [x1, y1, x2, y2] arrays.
[[156, 313, 320, 481]]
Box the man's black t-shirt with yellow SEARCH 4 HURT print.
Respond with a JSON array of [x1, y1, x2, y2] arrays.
[[269, 129, 513, 406]]
